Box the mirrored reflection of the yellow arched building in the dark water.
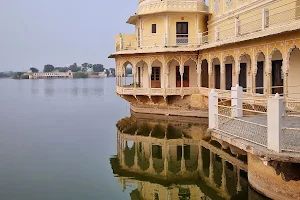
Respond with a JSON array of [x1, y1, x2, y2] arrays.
[[110, 114, 263, 200]]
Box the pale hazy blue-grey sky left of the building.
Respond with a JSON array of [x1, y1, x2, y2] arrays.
[[0, 0, 138, 71]]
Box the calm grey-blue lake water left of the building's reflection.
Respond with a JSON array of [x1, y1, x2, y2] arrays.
[[0, 78, 268, 200]]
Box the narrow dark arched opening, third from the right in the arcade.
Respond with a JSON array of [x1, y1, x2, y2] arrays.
[[255, 52, 265, 94]]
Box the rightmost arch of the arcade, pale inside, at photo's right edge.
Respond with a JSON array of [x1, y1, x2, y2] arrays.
[[287, 47, 300, 99]]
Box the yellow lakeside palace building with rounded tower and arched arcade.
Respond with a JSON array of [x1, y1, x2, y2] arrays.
[[110, 0, 300, 117]]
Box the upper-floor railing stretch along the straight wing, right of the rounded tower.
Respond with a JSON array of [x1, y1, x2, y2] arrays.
[[211, 0, 300, 45]]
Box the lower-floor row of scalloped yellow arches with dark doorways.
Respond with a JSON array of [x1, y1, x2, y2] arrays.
[[116, 37, 300, 96]]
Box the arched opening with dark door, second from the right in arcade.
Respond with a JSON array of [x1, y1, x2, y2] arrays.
[[271, 50, 284, 94]]
